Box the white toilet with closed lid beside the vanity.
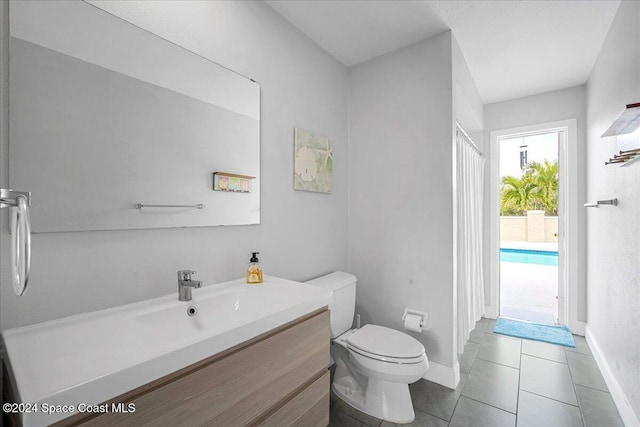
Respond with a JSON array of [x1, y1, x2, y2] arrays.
[[307, 271, 429, 424]]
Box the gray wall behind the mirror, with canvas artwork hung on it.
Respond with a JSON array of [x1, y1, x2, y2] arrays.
[[0, 1, 347, 329]]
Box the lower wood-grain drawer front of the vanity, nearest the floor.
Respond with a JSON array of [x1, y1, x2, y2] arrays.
[[258, 371, 331, 427]]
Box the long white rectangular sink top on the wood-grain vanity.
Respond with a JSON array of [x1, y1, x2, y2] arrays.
[[2, 276, 331, 426]]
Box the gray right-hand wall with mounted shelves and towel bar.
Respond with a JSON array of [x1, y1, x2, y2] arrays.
[[587, 1, 640, 418]]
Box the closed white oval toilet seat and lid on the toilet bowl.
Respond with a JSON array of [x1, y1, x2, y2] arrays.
[[344, 325, 426, 364]]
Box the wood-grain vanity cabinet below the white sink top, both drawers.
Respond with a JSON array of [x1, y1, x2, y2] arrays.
[[55, 308, 330, 427]]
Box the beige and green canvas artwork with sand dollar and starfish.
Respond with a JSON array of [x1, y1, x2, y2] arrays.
[[293, 128, 333, 193]]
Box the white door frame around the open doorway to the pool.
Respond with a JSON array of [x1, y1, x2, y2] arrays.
[[485, 119, 584, 334]]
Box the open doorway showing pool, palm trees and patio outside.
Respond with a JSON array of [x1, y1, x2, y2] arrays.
[[498, 130, 563, 325]]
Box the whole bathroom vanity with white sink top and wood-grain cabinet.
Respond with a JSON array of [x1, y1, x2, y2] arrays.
[[3, 276, 331, 426]]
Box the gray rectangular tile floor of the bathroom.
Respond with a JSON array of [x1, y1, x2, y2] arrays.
[[329, 319, 623, 427]]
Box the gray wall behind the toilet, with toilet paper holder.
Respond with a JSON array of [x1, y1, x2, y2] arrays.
[[349, 32, 456, 367]]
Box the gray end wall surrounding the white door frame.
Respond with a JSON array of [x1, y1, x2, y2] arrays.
[[484, 86, 587, 321]]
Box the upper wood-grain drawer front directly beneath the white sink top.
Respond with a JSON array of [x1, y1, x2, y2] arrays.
[[82, 310, 330, 426]]
